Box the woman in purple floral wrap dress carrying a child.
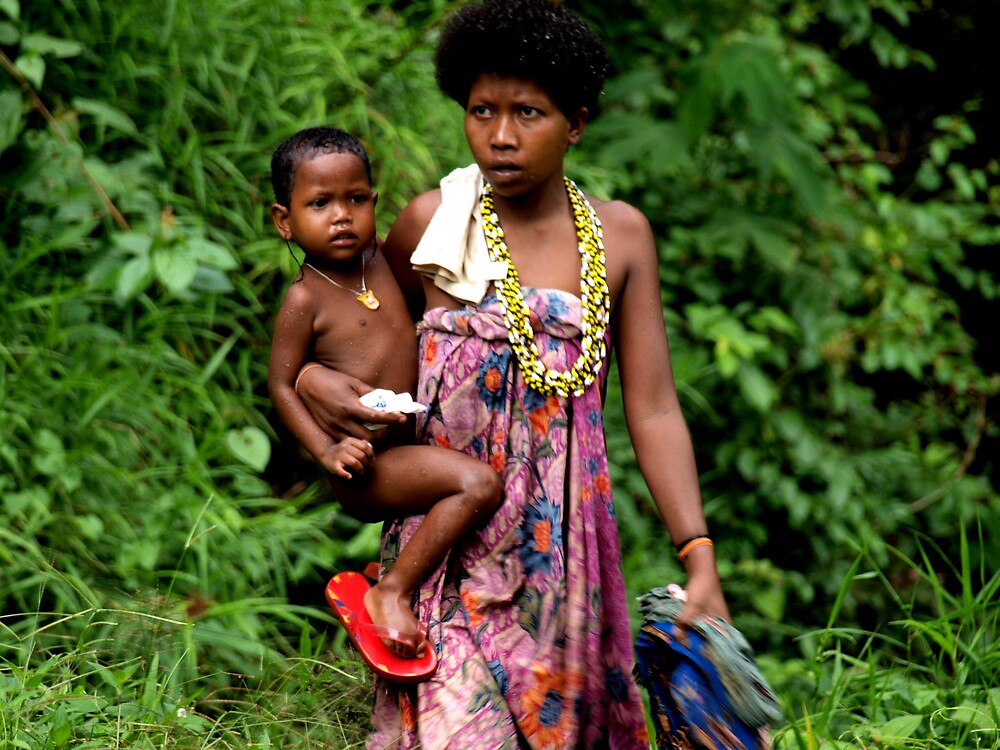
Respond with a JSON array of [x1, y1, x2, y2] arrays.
[[300, 0, 728, 750]]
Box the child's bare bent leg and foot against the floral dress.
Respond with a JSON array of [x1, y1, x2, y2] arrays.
[[338, 445, 503, 656]]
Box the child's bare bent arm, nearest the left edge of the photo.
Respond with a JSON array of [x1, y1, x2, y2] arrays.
[[267, 283, 374, 479]]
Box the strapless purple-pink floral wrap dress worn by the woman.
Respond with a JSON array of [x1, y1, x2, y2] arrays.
[[369, 289, 649, 750]]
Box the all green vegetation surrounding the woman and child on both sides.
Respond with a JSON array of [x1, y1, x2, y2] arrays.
[[0, 0, 1000, 748]]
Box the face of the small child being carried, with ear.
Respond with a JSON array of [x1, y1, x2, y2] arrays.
[[271, 153, 378, 263]]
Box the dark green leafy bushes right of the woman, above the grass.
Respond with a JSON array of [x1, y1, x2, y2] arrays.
[[578, 0, 1000, 642]]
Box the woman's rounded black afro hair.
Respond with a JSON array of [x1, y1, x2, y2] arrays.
[[434, 0, 609, 116]]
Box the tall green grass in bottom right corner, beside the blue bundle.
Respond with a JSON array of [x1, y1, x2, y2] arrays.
[[776, 532, 1000, 750]]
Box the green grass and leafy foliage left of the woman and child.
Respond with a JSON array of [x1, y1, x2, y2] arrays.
[[0, 0, 459, 747]]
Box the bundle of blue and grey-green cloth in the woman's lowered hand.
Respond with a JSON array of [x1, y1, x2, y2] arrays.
[[635, 588, 782, 750]]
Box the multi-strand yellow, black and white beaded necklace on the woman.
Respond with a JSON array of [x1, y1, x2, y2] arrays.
[[479, 177, 611, 396]]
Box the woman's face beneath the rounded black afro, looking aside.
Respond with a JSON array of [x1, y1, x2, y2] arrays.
[[465, 73, 587, 197]]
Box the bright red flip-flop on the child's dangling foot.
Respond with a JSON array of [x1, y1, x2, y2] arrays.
[[326, 573, 437, 682]]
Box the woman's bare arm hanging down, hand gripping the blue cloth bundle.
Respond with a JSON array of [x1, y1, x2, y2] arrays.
[[606, 203, 729, 622]]
